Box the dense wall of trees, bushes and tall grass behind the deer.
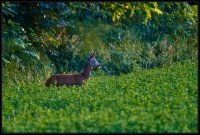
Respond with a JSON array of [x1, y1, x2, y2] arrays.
[[2, 2, 198, 83]]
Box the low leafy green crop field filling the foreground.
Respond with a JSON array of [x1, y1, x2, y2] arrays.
[[2, 62, 198, 133]]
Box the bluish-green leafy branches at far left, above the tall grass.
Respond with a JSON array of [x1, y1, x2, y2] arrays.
[[2, 2, 43, 75]]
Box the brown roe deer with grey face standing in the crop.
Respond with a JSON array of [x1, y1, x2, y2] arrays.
[[45, 52, 100, 87]]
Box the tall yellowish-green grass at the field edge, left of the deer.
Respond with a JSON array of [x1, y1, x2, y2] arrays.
[[2, 58, 52, 85]]
